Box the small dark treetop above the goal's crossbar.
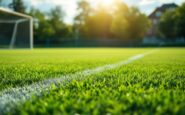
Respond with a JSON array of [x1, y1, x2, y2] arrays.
[[9, 0, 26, 13]]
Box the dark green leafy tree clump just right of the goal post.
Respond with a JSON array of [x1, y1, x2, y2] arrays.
[[29, 6, 72, 45]]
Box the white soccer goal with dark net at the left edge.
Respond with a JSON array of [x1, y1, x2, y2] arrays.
[[0, 8, 33, 49]]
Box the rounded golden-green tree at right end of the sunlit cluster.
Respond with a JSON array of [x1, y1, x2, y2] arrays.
[[111, 1, 150, 41]]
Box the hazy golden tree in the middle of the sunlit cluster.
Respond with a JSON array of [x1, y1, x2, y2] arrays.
[[85, 6, 112, 39]]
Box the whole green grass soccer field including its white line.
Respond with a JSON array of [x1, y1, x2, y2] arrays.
[[0, 48, 185, 115]]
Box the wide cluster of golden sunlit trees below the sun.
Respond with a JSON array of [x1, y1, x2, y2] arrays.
[[74, 0, 150, 41]]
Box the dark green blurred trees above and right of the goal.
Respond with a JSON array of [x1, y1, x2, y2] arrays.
[[0, 0, 74, 44]]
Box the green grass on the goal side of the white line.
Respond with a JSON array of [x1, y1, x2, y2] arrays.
[[0, 48, 150, 91]]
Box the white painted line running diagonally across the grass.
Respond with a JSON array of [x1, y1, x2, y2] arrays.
[[0, 50, 157, 114]]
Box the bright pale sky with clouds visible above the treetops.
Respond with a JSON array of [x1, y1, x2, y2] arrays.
[[1, 0, 185, 23]]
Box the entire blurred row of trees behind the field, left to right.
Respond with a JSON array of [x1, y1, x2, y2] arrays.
[[0, 0, 185, 43]]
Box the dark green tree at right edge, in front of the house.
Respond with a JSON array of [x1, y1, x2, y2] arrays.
[[158, 3, 185, 40]]
